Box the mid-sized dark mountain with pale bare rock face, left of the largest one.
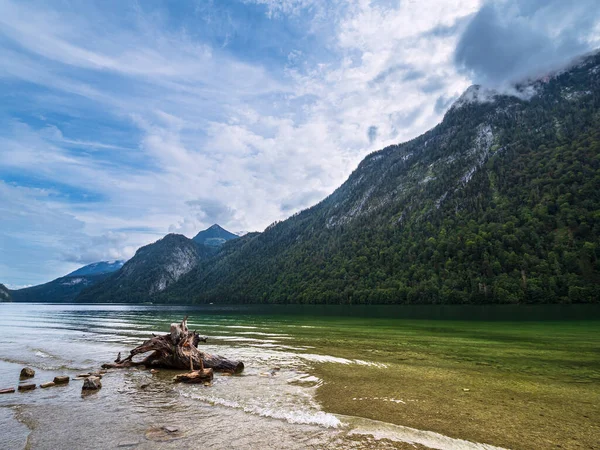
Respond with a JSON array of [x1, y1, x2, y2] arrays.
[[76, 234, 215, 302]]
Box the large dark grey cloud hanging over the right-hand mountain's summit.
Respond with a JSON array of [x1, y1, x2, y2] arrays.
[[455, 0, 600, 86]]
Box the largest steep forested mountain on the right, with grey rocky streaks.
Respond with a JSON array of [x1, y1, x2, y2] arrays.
[[157, 53, 600, 303]]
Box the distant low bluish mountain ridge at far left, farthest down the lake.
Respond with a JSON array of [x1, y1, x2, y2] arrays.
[[11, 261, 123, 303]]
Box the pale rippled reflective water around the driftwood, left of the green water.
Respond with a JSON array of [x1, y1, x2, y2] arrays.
[[0, 304, 596, 449]]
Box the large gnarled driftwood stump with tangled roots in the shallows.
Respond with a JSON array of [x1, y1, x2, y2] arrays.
[[102, 317, 244, 373]]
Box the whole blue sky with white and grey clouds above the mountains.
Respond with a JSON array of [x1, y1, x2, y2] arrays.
[[0, 0, 600, 288]]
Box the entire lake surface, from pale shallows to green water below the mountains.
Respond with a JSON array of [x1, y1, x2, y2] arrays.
[[0, 303, 600, 449]]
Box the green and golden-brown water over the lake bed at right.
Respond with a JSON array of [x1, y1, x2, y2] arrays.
[[282, 319, 600, 449]]
